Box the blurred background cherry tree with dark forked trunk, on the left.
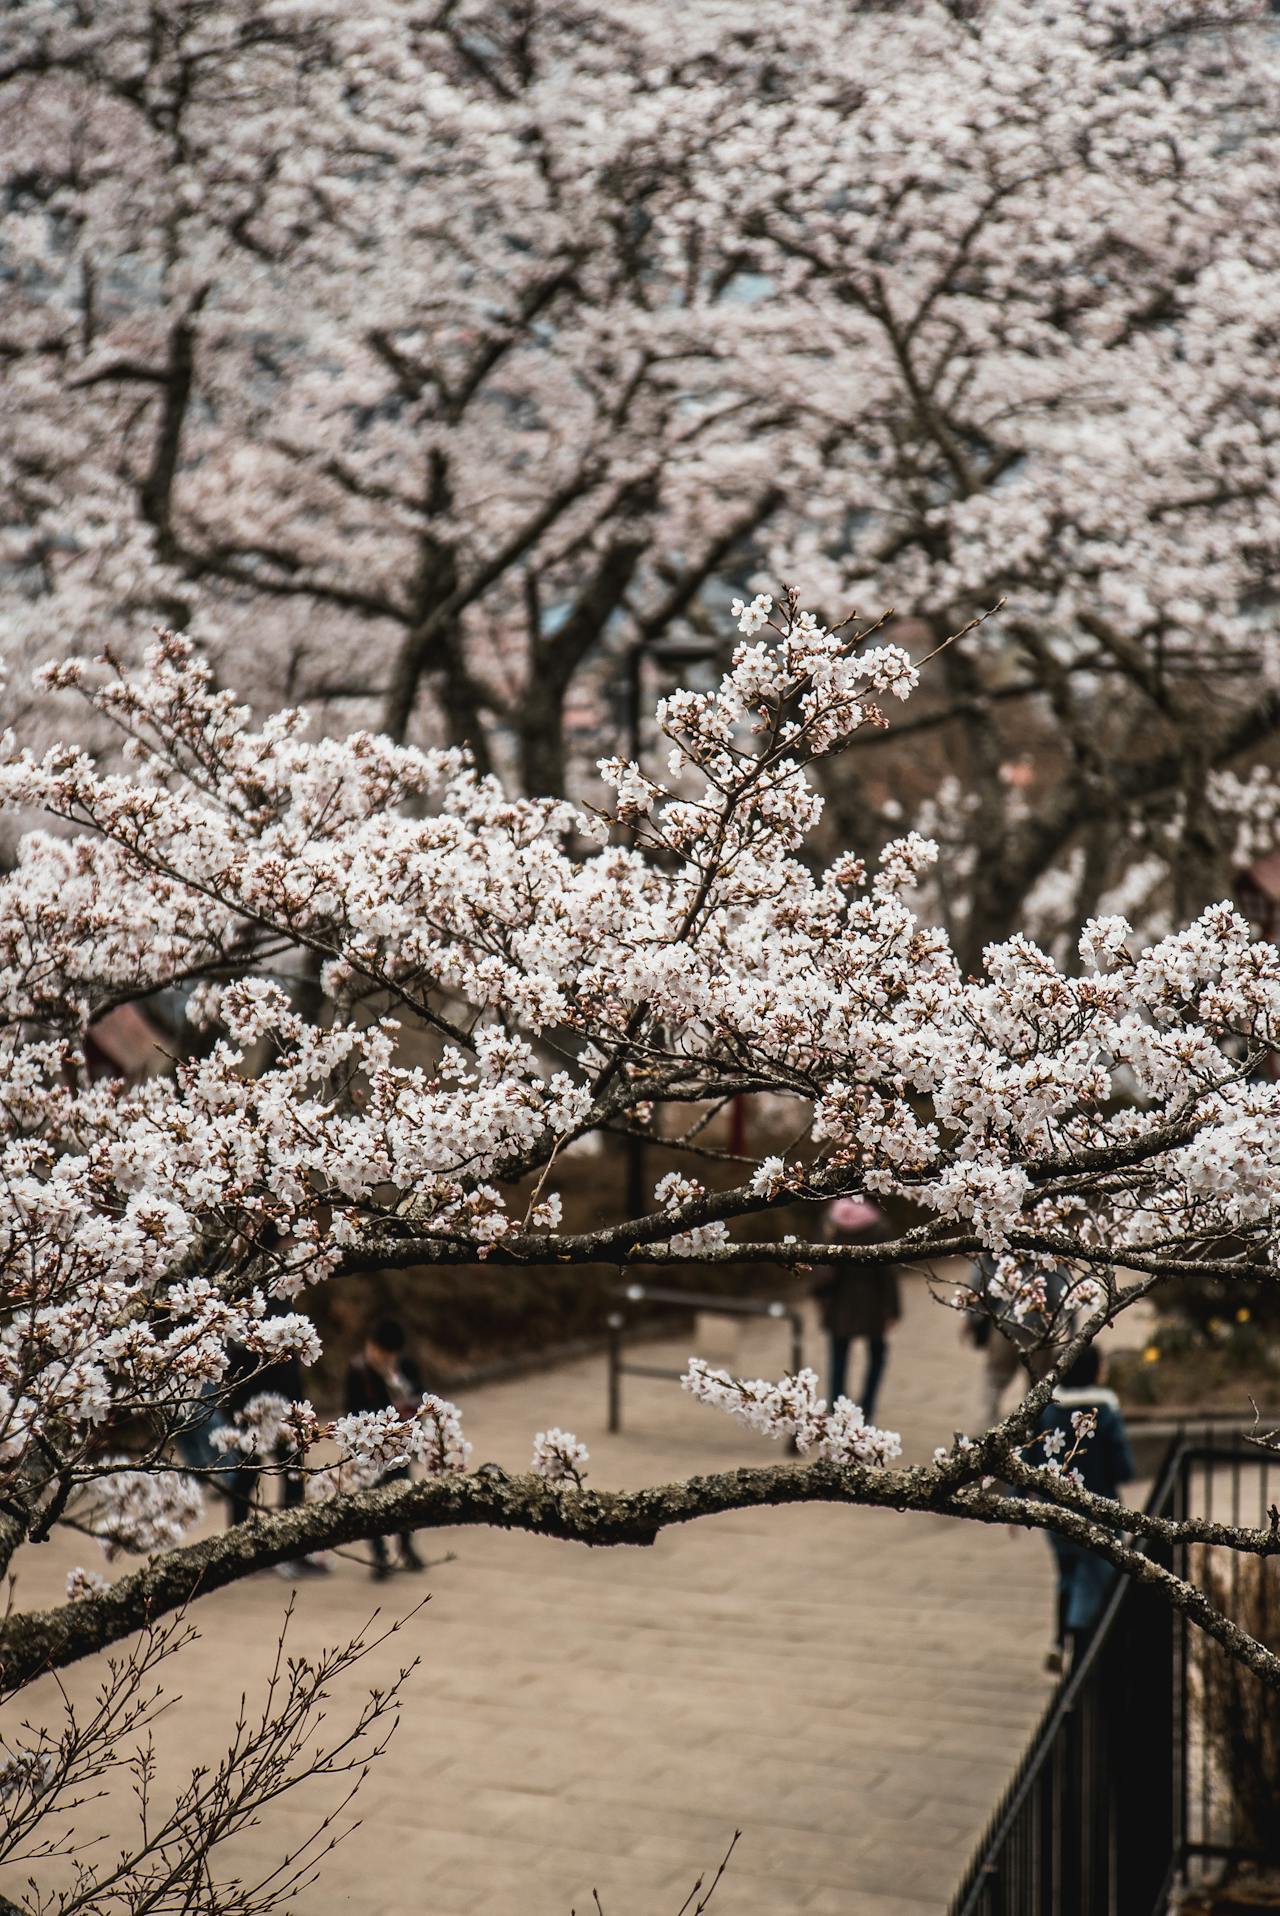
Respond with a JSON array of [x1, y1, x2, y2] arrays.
[[4, 0, 818, 793]]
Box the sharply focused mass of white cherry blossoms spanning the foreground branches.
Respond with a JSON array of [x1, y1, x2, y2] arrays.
[[0, 600, 1280, 1586]]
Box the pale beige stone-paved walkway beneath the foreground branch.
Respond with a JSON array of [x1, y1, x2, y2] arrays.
[[6, 1280, 1052, 1916]]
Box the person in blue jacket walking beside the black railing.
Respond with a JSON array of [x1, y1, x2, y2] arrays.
[[1031, 1343, 1134, 1673]]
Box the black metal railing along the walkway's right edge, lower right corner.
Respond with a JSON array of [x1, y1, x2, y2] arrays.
[[950, 1433, 1278, 1916]]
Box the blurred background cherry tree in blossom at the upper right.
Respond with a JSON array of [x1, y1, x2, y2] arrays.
[[705, 4, 1280, 966]]
